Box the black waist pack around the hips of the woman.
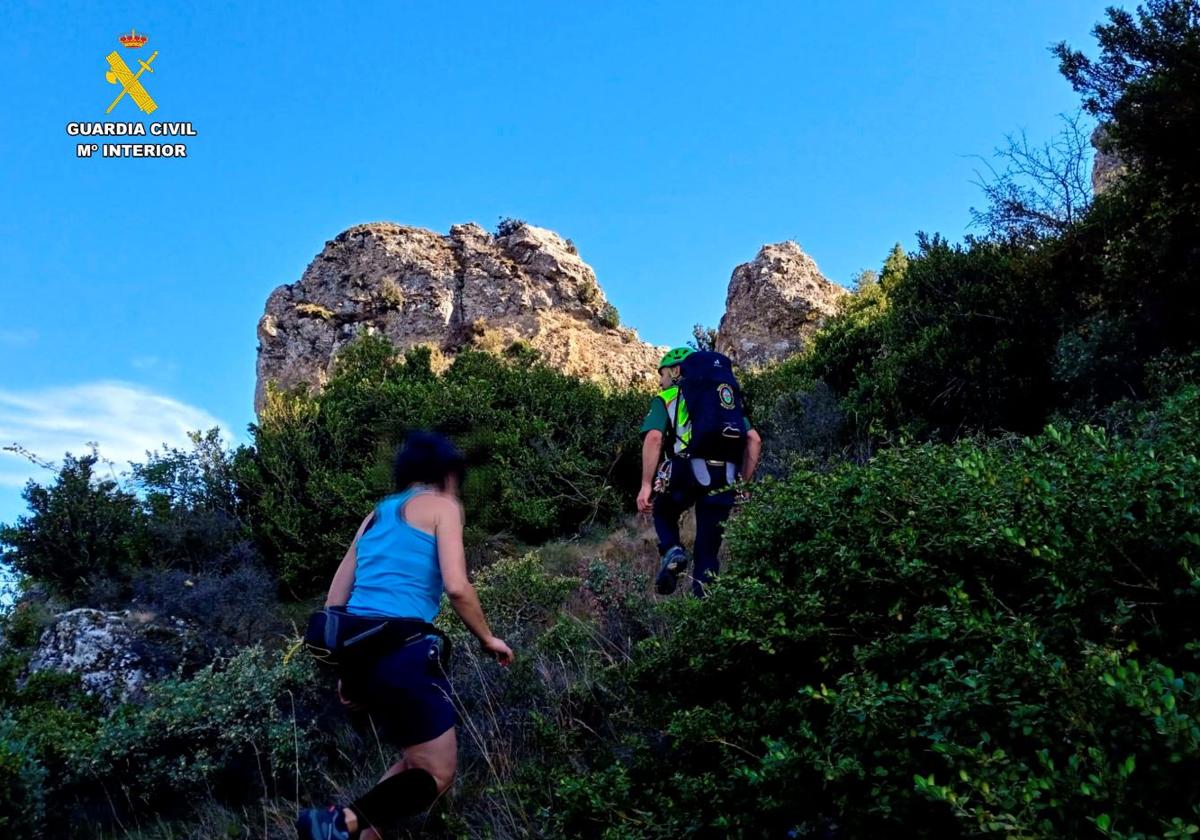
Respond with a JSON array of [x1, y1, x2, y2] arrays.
[[304, 607, 450, 668]]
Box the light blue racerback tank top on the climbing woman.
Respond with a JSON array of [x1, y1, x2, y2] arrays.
[[346, 487, 442, 622]]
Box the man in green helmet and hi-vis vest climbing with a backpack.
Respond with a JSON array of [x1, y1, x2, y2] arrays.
[[637, 347, 762, 598]]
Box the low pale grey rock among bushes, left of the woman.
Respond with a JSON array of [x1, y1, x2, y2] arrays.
[[29, 608, 205, 709]]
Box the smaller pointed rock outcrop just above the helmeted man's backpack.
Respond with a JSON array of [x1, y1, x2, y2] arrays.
[[716, 242, 847, 367]]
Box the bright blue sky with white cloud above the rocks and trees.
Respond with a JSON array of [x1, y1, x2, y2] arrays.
[[0, 0, 1105, 521]]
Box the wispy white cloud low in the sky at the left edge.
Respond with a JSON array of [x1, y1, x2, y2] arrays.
[[0, 382, 230, 501]]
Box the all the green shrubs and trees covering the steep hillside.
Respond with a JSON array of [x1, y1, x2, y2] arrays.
[[0, 0, 1200, 840]]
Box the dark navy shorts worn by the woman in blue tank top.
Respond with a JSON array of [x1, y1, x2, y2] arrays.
[[342, 637, 458, 748]]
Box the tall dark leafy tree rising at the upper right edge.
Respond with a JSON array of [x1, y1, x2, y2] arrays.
[[1054, 0, 1200, 376]]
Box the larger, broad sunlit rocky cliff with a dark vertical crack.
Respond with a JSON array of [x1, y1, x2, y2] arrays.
[[254, 222, 661, 410]]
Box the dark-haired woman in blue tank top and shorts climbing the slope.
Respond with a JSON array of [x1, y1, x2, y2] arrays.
[[296, 432, 512, 840]]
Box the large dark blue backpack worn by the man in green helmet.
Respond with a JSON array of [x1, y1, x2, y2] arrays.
[[679, 350, 746, 463]]
